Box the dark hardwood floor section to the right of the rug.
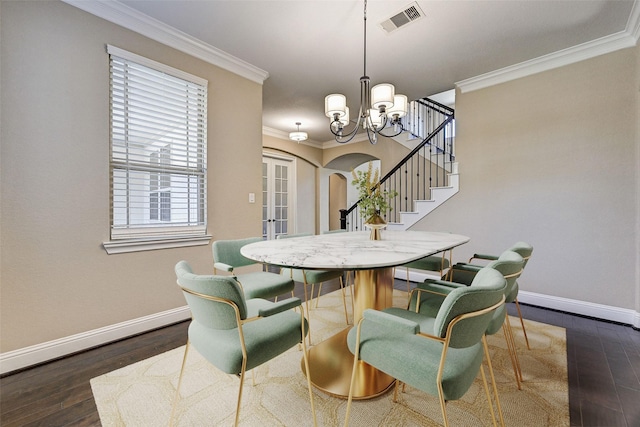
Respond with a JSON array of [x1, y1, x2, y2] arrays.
[[509, 304, 640, 427]]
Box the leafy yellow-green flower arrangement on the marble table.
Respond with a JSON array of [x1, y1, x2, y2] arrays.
[[351, 162, 398, 222]]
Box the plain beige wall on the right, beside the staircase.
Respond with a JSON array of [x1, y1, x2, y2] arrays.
[[414, 47, 640, 312]]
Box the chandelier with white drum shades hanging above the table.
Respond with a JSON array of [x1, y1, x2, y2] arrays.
[[324, 0, 407, 144]]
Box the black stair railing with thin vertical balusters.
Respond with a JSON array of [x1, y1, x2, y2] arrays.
[[340, 98, 455, 231]]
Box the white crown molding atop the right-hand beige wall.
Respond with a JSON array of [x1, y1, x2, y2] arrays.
[[456, 0, 640, 93]]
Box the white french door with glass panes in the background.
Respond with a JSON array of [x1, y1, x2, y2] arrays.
[[262, 156, 295, 240]]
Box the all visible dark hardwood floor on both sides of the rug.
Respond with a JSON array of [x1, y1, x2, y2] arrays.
[[0, 281, 640, 427]]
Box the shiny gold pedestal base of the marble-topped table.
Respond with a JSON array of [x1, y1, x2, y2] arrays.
[[301, 268, 395, 399]]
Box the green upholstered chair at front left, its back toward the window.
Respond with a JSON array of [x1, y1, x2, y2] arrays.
[[171, 261, 316, 425]]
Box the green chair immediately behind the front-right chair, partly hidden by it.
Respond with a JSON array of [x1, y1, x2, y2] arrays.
[[400, 251, 524, 389]]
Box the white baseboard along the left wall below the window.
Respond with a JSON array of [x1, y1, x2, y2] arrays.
[[0, 306, 191, 374]]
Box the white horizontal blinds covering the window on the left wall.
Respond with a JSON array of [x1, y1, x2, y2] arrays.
[[107, 46, 207, 240]]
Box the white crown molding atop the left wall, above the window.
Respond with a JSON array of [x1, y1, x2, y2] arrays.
[[62, 0, 269, 84]]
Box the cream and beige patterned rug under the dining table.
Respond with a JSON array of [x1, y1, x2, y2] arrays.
[[91, 290, 569, 427]]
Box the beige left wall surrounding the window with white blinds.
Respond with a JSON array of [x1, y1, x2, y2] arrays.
[[0, 1, 262, 352]]
